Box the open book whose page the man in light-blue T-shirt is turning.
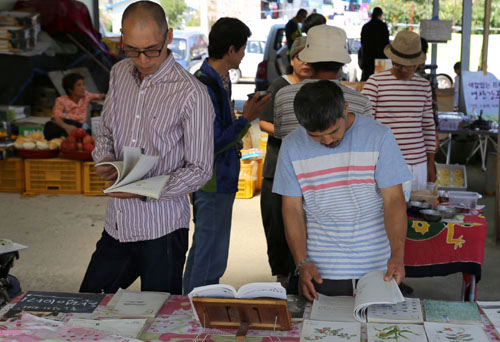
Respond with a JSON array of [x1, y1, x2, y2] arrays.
[[311, 271, 410, 323]]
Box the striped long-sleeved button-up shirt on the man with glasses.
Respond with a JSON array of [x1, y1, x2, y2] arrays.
[[93, 54, 214, 242]]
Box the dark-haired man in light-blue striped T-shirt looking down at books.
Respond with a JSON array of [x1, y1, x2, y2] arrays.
[[273, 80, 410, 300]]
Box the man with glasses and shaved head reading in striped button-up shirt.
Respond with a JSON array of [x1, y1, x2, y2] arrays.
[[80, 1, 214, 294]]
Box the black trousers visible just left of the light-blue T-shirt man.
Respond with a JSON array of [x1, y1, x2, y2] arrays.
[[260, 178, 295, 275]]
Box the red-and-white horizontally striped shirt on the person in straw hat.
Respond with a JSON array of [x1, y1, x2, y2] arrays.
[[362, 70, 436, 165]]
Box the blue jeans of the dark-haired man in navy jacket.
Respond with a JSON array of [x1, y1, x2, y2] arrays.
[[183, 190, 236, 294]]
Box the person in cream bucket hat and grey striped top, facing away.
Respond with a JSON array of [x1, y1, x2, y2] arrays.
[[274, 25, 373, 139]]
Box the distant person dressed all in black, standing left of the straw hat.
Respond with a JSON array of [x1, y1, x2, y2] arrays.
[[361, 7, 389, 81]]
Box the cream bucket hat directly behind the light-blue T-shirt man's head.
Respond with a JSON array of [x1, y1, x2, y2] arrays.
[[299, 25, 351, 64]]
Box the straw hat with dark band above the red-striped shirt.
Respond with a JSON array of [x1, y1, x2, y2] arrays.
[[384, 31, 425, 66]]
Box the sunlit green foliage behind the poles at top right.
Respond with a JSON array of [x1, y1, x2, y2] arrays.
[[371, 0, 500, 34]]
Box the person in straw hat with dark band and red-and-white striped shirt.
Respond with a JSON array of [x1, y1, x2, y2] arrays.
[[362, 31, 436, 189]]
